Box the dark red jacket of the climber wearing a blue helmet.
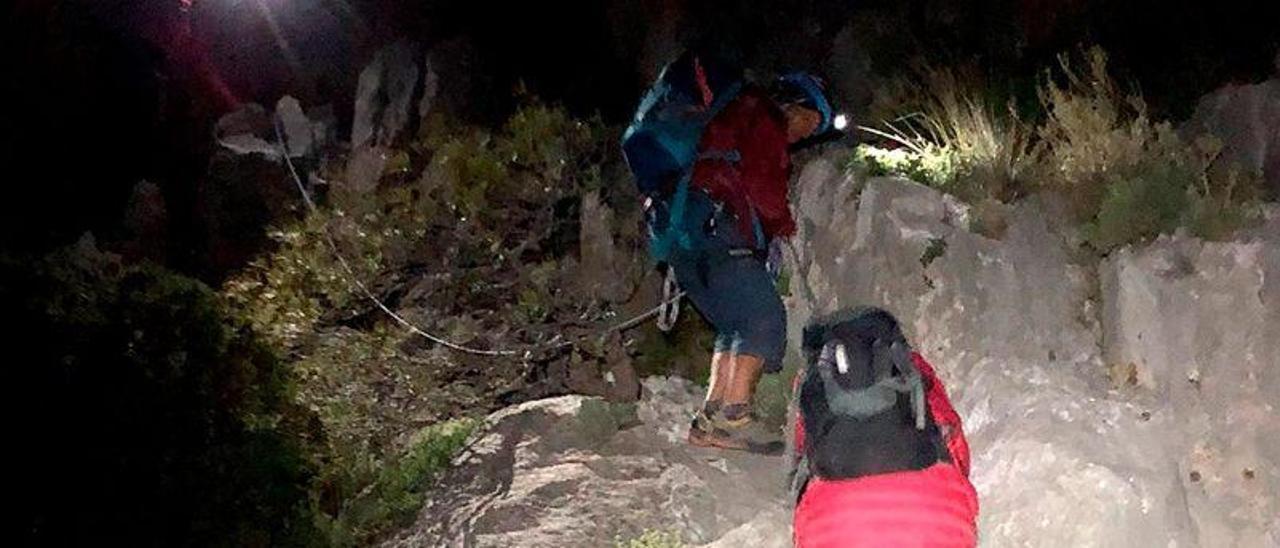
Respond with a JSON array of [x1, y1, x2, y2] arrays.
[[692, 88, 796, 239]]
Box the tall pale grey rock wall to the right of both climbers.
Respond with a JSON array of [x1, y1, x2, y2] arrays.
[[788, 148, 1280, 545]]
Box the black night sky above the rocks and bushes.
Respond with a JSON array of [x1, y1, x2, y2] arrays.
[[0, 0, 1280, 271]]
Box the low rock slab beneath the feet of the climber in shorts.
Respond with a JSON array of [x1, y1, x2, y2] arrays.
[[387, 378, 791, 548]]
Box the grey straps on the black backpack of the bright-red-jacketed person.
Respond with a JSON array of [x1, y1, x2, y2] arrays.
[[818, 341, 925, 430]]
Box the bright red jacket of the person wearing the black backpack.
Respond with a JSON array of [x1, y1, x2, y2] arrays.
[[794, 353, 978, 548]]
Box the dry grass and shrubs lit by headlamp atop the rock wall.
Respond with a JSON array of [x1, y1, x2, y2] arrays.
[[852, 47, 1262, 254]]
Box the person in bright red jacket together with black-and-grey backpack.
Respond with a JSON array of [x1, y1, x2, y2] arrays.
[[787, 307, 978, 548]]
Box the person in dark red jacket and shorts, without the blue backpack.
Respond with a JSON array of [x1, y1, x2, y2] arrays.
[[671, 68, 831, 453]]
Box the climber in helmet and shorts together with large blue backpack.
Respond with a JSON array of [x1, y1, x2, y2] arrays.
[[623, 52, 835, 453]]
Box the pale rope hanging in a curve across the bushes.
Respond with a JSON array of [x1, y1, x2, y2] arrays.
[[271, 115, 685, 359]]
